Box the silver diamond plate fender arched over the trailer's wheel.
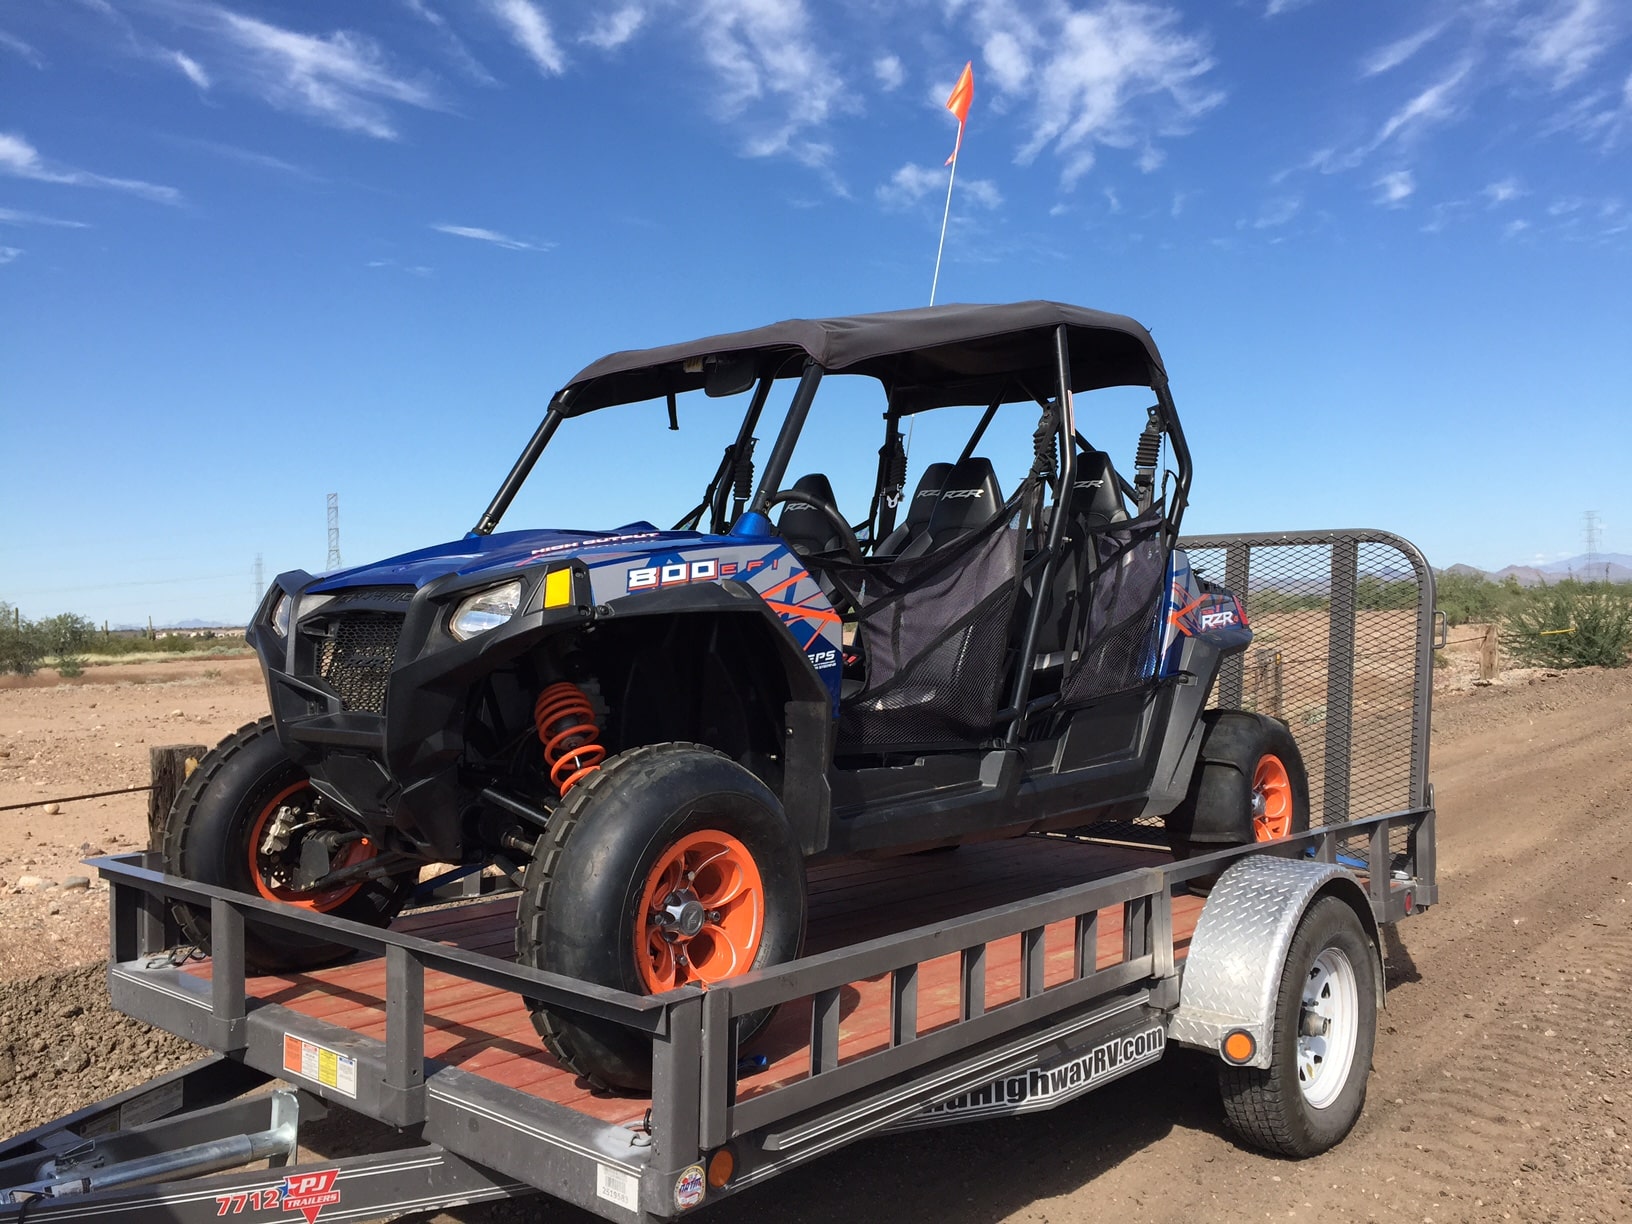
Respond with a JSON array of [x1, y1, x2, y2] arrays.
[[1169, 855, 1382, 1067]]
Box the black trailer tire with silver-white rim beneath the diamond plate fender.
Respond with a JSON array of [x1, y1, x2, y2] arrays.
[[1219, 896, 1377, 1157]]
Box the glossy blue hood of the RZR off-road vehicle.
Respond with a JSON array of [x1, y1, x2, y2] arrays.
[[310, 522, 720, 592]]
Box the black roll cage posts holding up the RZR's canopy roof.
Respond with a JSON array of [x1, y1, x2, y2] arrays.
[[472, 323, 1191, 747]]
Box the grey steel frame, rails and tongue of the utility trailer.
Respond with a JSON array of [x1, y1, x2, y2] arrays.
[[0, 532, 1438, 1224]]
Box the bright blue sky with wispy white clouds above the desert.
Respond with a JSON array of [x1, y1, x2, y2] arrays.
[[0, 0, 1632, 622]]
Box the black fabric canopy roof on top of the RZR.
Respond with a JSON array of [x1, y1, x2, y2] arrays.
[[558, 302, 1162, 416]]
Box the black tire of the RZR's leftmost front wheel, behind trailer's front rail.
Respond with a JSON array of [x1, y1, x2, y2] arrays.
[[163, 718, 413, 973]]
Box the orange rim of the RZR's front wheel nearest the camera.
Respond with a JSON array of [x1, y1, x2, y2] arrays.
[[635, 829, 765, 994]]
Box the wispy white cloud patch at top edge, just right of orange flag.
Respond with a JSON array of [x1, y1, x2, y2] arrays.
[[973, 0, 1224, 188]]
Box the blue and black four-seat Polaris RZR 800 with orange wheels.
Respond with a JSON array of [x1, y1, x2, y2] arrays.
[[165, 302, 1309, 1089]]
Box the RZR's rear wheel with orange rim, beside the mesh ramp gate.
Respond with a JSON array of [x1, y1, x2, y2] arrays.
[[1167, 710, 1309, 858]]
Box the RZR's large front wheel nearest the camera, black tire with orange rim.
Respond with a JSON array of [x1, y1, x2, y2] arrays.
[[516, 744, 805, 1092]]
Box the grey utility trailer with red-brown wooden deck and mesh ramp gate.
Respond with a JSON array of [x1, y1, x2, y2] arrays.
[[0, 530, 1438, 1224]]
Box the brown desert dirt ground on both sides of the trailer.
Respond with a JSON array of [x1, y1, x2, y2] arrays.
[[0, 635, 1632, 1224]]
